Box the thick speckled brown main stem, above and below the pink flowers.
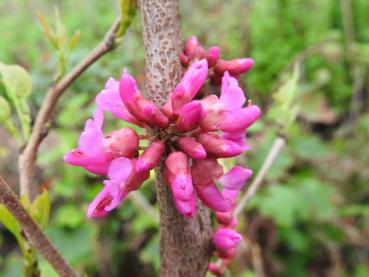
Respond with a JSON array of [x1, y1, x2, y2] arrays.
[[138, 0, 212, 277]]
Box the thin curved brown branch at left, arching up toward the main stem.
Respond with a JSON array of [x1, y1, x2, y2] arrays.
[[18, 17, 121, 197]]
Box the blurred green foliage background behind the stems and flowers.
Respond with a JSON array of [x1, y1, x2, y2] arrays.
[[0, 0, 369, 277]]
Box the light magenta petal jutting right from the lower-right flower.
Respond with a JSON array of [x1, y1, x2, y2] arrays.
[[219, 166, 252, 190]]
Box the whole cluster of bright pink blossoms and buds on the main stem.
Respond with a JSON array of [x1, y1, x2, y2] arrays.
[[64, 37, 260, 274]]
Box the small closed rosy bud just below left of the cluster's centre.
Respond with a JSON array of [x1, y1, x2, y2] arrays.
[[136, 140, 165, 172]]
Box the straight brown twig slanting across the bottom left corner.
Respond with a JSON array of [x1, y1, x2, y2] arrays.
[[0, 176, 77, 277]]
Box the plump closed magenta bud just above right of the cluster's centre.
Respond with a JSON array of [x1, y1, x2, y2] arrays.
[[176, 101, 205, 133]]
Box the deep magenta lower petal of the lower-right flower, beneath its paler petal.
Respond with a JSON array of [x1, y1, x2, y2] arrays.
[[196, 183, 232, 212]]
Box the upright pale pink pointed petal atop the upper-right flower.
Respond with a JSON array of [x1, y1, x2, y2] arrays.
[[219, 71, 246, 111]]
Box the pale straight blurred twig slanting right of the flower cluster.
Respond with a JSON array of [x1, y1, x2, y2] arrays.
[[234, 137, 286, 217]]
